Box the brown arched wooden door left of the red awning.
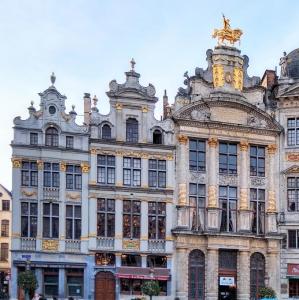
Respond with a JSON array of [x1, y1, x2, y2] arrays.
[[95, 272, 115, 300]]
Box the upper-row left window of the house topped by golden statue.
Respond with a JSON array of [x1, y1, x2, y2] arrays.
[[189, 139, 206, 172]]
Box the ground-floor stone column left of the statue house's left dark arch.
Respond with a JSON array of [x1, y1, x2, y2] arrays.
[[175, 248, 188, 300]]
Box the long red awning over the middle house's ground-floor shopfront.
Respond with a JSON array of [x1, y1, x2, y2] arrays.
[[116, 267, 170, 280]]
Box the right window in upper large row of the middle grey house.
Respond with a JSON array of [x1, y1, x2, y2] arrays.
[[148, 159, 166, 188]]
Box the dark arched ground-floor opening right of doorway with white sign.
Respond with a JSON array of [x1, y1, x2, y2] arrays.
[[250, 252, 265, 300]]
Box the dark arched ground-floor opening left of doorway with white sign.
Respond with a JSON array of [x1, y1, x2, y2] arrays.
[[188, 250, 205, 300]]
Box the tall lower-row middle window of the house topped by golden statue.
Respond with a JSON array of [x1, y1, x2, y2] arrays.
[[219, 186, 237, 232]]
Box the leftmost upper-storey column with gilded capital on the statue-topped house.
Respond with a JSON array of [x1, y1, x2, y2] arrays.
[[177, 135, 189, 227]]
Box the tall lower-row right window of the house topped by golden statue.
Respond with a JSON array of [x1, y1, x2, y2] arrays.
[[250, 189, 265, 235]]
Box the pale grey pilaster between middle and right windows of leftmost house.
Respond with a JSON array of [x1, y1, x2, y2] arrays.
[[59, 162, 66, 252]]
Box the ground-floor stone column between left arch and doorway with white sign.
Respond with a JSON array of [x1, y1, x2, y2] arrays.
[[206, 249, 218, 300]]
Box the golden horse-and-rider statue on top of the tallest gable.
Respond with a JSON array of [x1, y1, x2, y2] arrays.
[[212, 15, 243, 45]]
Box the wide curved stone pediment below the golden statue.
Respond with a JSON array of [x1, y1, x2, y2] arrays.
[[173, 99, 282, 132]]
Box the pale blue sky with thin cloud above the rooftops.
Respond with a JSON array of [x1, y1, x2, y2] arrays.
[[0, 0, 299, 189]]
